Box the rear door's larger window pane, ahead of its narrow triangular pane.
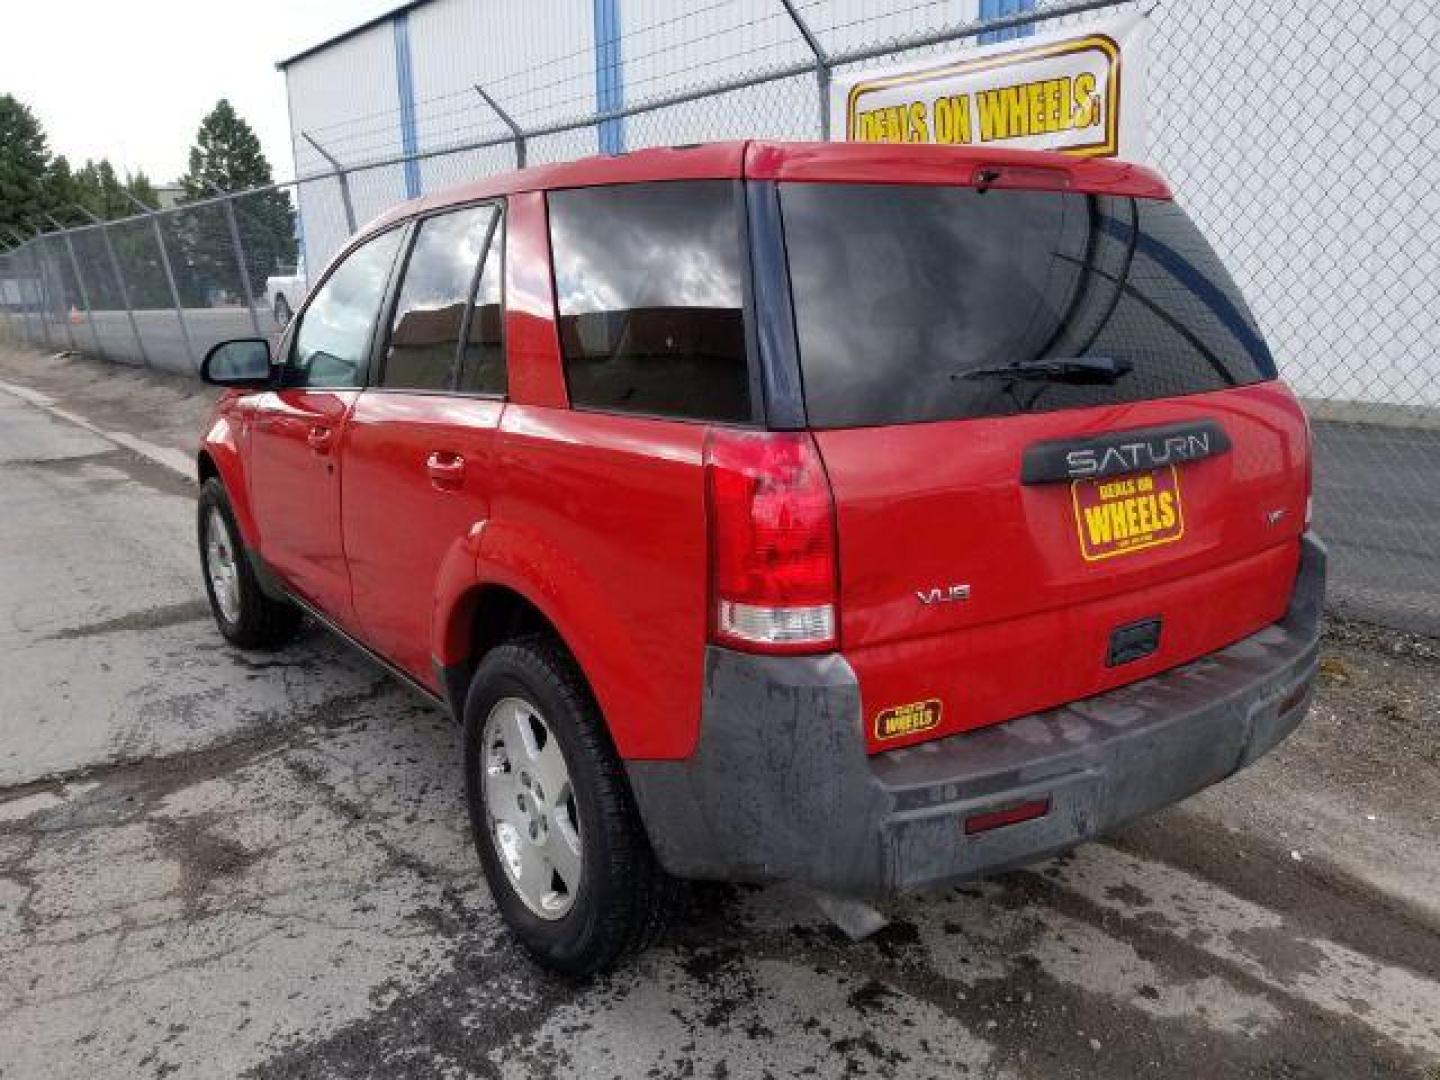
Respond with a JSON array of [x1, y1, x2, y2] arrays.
[[380, 206, 497, 390]]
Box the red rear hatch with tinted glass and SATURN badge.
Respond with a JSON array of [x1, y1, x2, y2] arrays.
[[780, 183, 1309, 750]]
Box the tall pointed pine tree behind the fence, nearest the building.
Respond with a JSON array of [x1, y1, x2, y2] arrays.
[[180, 98, 297, 305]]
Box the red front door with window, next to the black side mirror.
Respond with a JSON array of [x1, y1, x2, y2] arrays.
[[251, 229, 402, 628]]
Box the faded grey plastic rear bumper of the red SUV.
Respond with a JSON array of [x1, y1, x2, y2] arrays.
[[626, 534, 1325, 897]]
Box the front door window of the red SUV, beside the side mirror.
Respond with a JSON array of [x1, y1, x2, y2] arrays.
[[285, 229, 403, 387]]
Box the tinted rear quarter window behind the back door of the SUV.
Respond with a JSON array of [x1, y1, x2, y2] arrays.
[[550, 180, 752, 420]]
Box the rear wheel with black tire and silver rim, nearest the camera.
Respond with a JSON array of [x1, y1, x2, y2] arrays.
[[465, 635, 678, 976]]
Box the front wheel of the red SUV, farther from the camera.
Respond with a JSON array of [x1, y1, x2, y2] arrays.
[[196, 477, 301, 649]]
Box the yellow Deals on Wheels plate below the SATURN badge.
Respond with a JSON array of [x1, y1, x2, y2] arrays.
[[1070, 465, 1185, 563]]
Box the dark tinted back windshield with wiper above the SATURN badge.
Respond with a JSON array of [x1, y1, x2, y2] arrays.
[[780, 184, 1274, 428]]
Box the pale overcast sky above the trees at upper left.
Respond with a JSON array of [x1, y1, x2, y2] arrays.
[[0, 0, 396, 183]]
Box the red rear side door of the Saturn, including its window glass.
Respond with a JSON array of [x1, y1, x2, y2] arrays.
[[343, 203, 505, 685]]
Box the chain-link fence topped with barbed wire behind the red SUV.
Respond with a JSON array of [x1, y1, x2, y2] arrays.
[[0, 0, 1440, 634]]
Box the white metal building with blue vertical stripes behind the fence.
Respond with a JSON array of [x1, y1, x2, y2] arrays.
[[279, 0, 1440, 423]]
